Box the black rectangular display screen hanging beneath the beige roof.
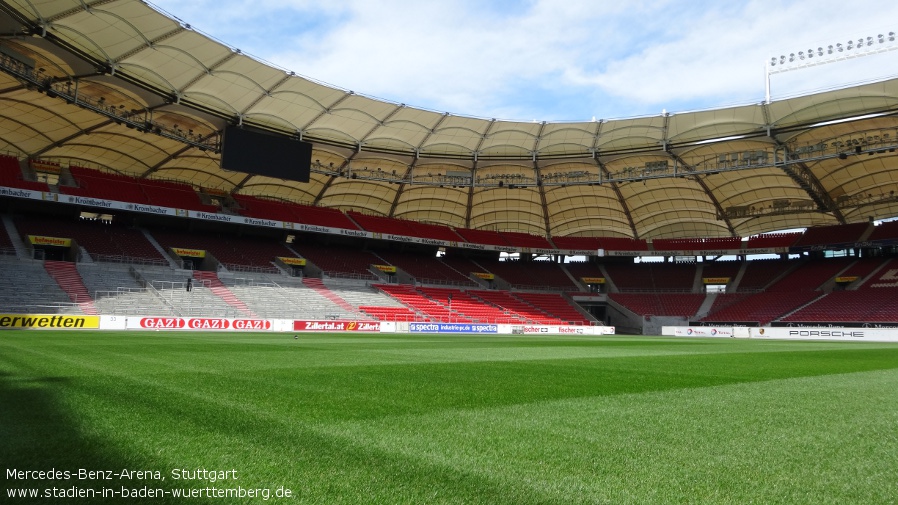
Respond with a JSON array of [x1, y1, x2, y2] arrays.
[[221, 126, 312, 182]]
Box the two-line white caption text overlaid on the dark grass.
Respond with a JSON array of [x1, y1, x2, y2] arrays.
[[7, 468, 295, 503]]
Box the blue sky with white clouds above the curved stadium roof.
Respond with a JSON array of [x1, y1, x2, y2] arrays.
[[152, 0, 898, 121]]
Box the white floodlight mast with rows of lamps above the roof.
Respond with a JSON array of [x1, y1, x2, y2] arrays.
[[764, 31, 898, 103]]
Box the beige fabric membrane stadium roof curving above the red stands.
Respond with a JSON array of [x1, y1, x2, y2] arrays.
[[0, 0, 898, 239]]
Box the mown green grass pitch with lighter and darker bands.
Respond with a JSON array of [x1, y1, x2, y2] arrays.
[[0, 331, 898, 505]]
